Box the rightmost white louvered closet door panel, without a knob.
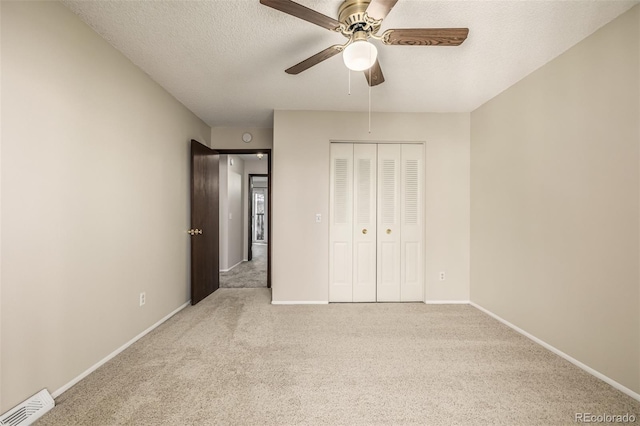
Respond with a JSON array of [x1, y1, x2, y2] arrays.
[[400, 144, 424, 302]]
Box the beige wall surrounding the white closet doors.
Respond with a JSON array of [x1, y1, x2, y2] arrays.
[[270, 111, 469, 302]]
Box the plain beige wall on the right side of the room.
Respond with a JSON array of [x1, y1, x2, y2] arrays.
[[471, 6, 640, 392]]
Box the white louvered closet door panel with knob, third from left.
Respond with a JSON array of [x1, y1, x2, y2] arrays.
[[377, 144, 402, 302]]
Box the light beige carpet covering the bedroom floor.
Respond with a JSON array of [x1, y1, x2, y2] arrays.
[[37, 289, 640, 426]]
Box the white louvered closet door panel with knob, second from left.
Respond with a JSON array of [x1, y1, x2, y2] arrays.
[[353, 144, 377, 302]]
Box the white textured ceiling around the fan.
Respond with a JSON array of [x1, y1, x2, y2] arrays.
[[63, 0, 638, 127]]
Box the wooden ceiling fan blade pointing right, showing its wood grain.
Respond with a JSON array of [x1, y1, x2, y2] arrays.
[[382, 28, 469, 46]]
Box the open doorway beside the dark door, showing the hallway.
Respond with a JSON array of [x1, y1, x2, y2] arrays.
[[217, 149, 271, 288]]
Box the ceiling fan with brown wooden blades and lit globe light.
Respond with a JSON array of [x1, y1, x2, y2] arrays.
[[260, 0, 469, 86]]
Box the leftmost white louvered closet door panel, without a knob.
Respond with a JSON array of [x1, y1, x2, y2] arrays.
[[329, 144, 353, 302]]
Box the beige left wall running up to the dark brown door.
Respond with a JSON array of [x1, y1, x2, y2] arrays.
[[0, 1, 211, 412]]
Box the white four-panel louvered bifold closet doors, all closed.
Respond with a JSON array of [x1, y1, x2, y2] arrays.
[[329, 143, 424, 302]]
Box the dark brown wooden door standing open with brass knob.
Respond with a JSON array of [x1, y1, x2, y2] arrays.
[[189, 140, 220, 305]]
